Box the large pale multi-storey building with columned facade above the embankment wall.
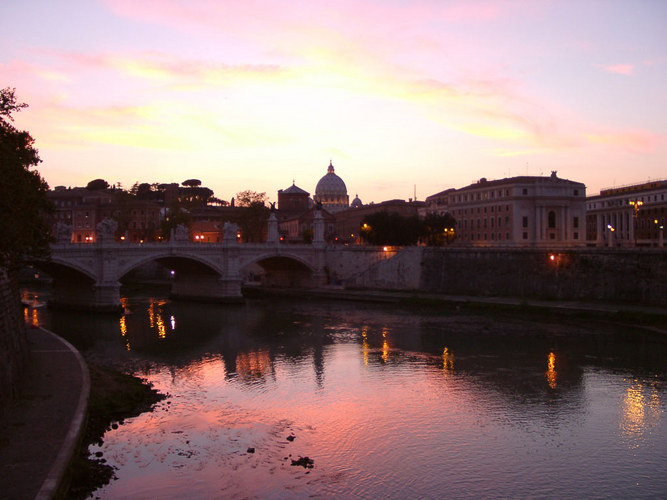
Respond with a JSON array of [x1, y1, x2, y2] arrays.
[[426, 172, 586, 247]]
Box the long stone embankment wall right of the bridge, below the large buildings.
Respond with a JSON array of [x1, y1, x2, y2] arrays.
[[346, 247, 667, 307]]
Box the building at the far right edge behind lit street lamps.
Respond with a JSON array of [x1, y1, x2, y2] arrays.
[[586, 180, 667, 247]]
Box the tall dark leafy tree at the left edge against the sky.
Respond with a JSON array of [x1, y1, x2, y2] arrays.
[[0, 88, 53, 271]]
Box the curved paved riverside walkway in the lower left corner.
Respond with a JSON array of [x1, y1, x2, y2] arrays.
[[0, 329, 90, 500]]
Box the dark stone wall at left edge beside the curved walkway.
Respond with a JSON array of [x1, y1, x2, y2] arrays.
[[0, 269, 28, 413]]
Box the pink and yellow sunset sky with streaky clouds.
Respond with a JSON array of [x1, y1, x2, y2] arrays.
[[0, 0, 667, 203]]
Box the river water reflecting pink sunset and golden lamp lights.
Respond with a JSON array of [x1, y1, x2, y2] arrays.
[[26, 294, 667, 499]]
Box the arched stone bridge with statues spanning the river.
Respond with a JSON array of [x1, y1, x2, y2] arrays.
[[35, 239, 396, 310]]
